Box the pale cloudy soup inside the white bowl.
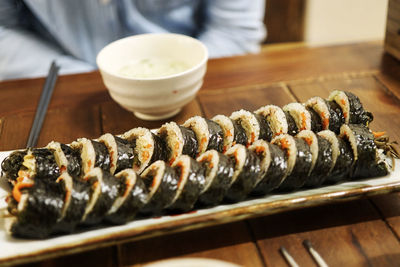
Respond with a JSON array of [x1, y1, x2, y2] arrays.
[[118, 58, 191, 78]]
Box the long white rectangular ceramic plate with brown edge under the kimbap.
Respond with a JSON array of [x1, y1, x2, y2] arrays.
[[0, 152, 400, 264]]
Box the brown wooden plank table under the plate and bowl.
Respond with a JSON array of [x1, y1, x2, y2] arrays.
[[0, 40, 400, 266]]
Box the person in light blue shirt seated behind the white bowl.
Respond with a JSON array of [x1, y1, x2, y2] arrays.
[[0, 0, 266, 80]]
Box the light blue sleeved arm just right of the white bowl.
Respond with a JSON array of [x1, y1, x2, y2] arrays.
[[197, 0, 266, 57]]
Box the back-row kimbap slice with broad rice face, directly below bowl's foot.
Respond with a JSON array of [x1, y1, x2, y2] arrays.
[[122, 127, 167, 174]]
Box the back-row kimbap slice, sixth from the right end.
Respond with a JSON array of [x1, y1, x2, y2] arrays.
[[212, 115, 247, 152]]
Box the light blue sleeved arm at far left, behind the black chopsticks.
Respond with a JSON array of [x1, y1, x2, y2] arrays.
[[0, 0, 94, 80]]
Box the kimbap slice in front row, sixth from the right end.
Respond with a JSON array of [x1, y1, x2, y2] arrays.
[[225, 144, 261, 202]]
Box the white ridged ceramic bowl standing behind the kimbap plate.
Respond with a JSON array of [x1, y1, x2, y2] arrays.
[[97, 33, 208, 120]]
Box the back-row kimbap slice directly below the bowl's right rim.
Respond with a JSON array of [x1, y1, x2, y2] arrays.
[[183, 116, 224, 156]]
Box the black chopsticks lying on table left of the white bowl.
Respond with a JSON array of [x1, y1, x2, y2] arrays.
[[26, 61, 60, 148]]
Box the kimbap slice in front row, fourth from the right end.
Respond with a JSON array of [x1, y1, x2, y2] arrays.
[[272, 134, 312, 191]]
